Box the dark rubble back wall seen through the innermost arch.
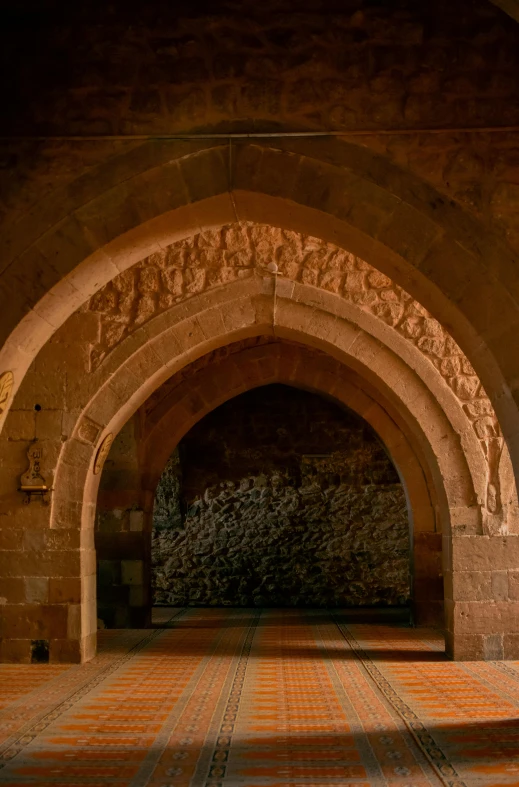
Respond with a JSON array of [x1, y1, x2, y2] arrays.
[[152, 385, 410, 606]]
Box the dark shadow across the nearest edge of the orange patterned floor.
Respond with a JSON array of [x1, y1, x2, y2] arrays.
[[8, 719, 519, 787]]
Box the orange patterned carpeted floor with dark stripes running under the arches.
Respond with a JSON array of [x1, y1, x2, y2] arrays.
[[0, 609, 519, 787]]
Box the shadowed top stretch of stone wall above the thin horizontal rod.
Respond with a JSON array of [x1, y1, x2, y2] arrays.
[[2, 0, 518, 134]]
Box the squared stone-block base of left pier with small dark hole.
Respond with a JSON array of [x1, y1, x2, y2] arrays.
[[0, 524, 95, 663]]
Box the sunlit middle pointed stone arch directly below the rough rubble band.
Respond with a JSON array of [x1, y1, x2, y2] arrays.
[[2, 217, 516, 660]]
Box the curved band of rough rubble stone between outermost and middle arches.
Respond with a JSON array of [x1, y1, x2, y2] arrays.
[[86, 222, 503, 514]]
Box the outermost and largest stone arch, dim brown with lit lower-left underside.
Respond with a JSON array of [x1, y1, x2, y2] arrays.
[[2, 141, 519, 480]]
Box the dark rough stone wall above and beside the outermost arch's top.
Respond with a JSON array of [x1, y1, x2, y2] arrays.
[[0, 0, 519, 252]]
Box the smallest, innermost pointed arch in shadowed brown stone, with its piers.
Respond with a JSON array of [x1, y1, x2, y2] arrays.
[[96, 337, 449, 648]]
